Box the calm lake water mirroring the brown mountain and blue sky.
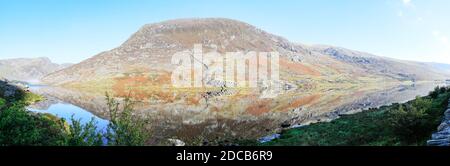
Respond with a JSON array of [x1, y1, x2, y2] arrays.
[[29, 82, 443, 144]]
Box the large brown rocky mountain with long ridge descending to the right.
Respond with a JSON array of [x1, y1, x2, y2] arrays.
[[43, 18, 449, 85]]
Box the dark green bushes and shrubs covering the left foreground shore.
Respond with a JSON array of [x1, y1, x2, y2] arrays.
[[0, 82, 149, 146]]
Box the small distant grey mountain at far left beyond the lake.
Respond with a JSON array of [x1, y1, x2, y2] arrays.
[[0, 58, 70, 83]]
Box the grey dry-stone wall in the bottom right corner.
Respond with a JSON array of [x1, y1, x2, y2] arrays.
[[427, 101, 450, 146]]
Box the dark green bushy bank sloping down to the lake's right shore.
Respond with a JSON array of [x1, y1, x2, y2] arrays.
[[255, 87, 450, 146]]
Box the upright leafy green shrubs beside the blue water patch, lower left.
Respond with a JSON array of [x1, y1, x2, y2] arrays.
[[57, 94, 149, 146]]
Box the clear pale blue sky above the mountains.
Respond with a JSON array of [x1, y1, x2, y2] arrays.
[[0, 0, 450, 64]]
